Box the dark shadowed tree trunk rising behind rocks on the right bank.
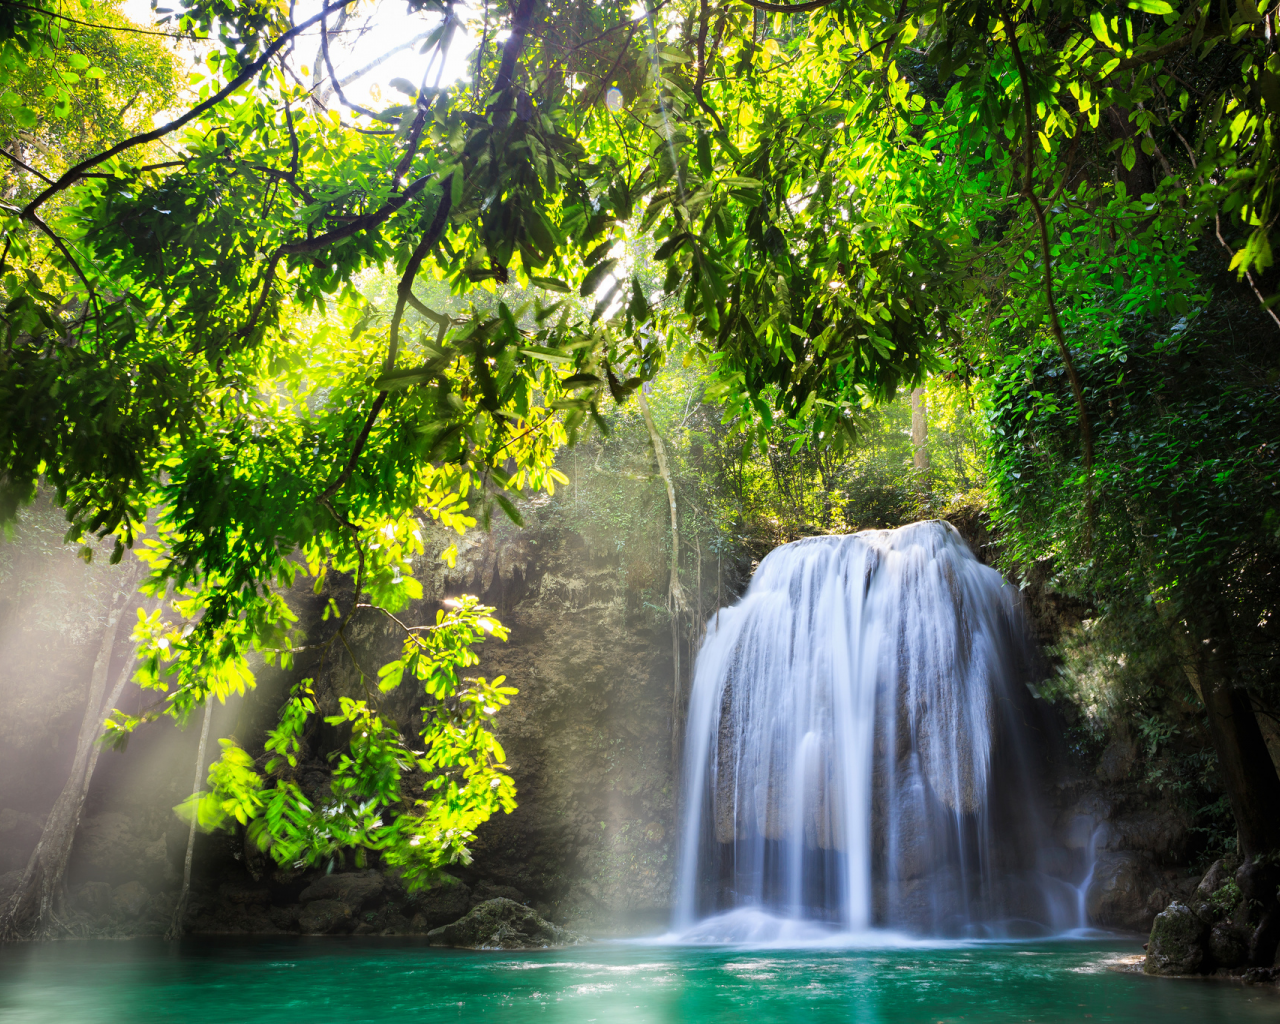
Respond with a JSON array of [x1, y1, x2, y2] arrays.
[[1187, 609, 1280, 966]]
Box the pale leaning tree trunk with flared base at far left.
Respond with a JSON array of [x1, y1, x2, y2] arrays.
[[0, 586, 133, 942]]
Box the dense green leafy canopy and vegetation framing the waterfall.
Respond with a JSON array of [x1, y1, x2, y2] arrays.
[[0, 0, 1280, 963]]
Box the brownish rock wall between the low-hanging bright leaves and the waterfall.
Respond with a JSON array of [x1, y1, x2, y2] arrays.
[[412, 516, 691, 933]]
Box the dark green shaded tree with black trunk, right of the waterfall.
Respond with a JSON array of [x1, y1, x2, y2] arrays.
[[993, 270, 1280, 963]]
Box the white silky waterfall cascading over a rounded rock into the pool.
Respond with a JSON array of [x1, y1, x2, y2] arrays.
[[676, 521, 1083, 940]]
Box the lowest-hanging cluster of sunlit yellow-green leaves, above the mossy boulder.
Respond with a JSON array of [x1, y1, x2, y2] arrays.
[[177, 596, 516, 887]]
